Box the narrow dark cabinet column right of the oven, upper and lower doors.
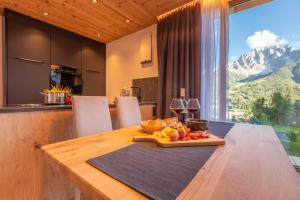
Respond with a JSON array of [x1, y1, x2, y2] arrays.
[[82, 39, 106, 96]]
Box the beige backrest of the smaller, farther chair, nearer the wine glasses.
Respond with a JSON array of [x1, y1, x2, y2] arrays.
[[116, 97, 142, 128]]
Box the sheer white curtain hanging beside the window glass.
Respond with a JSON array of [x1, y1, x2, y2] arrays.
[[201, 0, 228, 120]]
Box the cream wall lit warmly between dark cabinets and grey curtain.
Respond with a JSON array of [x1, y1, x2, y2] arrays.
[[106, 25, 158, 103]]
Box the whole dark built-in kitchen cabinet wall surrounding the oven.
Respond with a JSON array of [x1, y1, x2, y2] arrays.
[[5, 9, 106, 104]]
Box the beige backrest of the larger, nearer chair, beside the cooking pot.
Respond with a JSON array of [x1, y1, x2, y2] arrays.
[[72, 96, 112, 137]]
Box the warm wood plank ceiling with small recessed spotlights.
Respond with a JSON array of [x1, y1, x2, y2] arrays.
[[0, 0, 191, 43]]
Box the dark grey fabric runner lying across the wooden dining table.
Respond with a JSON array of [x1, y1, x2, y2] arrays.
[[88, 122, 234, 200]]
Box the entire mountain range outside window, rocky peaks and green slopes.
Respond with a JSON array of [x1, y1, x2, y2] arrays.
[[228, 46, 300, 116]]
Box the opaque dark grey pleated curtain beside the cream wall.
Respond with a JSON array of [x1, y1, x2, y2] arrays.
[[157, 2, 201, 118]]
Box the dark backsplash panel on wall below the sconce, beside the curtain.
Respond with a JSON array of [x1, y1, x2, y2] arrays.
[[132, 77, 158, 102]]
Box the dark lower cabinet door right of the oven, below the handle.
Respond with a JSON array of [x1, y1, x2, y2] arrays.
[[82, 69, 105, 96]]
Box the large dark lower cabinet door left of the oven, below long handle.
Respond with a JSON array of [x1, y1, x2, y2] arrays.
[[7, 58, 49, 104]]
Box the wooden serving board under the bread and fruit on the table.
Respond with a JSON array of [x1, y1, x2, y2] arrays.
[[133, 133, 225, 147]]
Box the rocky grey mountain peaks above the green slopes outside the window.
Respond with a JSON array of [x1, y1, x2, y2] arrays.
[[229, 46, 300, 77]]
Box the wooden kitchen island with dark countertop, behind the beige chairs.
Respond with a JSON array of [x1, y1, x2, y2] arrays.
[[0, 102, 156, 200]]
